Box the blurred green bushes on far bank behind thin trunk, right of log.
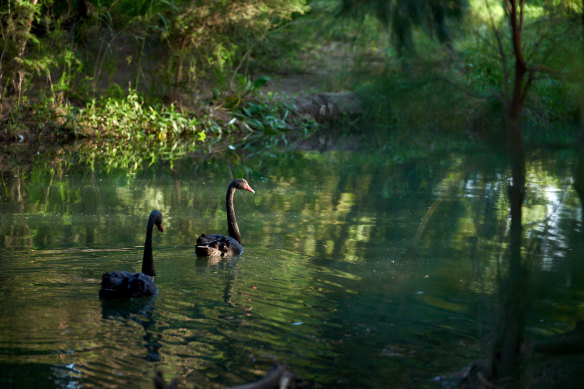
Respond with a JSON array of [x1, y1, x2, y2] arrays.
[[342, 0, 584, 149]]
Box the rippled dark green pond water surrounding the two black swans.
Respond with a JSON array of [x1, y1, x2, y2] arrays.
[[0, 148, 584, 388]]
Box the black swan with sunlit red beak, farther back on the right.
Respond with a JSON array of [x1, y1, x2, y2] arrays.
[[195, 178, 255, 257]]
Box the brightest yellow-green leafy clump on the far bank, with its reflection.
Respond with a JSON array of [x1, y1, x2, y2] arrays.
[[76, 91, 209, 172]]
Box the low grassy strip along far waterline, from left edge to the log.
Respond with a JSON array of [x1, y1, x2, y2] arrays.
[[2, 90, 318, 172]]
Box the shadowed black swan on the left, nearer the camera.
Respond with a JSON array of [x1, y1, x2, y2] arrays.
[[99, 210, 164, 299]]
